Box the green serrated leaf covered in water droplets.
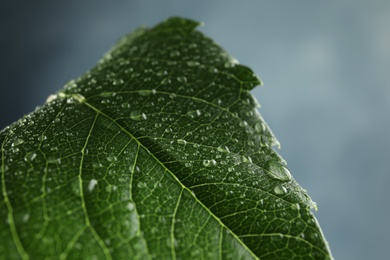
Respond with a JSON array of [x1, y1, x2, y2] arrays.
[[0, 18, 331, 259]]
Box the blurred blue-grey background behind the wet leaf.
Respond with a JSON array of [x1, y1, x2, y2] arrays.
[[0, 0, 390, 259]]
